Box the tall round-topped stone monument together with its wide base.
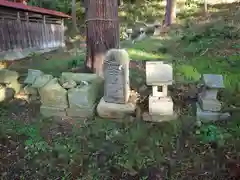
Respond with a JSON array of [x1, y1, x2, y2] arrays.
[[97, 49, 136, 118]]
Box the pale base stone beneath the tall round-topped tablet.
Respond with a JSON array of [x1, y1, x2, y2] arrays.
[[97, 98, 136, 119]]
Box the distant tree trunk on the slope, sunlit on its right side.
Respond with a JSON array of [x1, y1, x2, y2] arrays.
[[164, 0, 176, 26]]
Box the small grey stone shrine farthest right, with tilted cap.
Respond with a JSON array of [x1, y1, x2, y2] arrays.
[[197, 74, 230, 122]]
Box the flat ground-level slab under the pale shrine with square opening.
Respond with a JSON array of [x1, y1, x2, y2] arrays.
[[142, 113, 177, 122]]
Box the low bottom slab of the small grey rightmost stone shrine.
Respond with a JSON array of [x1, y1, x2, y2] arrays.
[[196, 103, 230, 122]]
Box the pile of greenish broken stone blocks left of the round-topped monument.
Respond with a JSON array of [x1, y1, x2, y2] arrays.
[[24, 69, 103, 118]]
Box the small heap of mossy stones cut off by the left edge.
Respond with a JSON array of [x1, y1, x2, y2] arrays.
[[0, 69, 22, 102]]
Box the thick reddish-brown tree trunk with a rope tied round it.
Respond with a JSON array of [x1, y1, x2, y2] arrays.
[[85, 0, 119, 76]]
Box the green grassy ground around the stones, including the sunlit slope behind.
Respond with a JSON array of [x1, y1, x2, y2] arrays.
[[0, 1, 240, 180]]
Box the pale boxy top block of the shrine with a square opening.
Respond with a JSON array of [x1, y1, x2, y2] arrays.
[[146, 61, 173, 86]]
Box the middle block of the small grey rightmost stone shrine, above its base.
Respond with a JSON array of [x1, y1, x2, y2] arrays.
[[199, 97, 222, 112]]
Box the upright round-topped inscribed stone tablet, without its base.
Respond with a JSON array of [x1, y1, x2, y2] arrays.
[[103, 49, 130, 104]]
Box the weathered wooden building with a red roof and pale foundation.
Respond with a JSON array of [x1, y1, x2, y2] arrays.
[[0, 0, 70, 60]]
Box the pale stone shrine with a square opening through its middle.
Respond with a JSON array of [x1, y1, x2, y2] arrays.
[[143, 61, 174, 122]]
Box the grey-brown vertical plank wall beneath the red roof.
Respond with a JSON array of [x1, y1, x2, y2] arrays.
[[0, 8, 64, 52]]
